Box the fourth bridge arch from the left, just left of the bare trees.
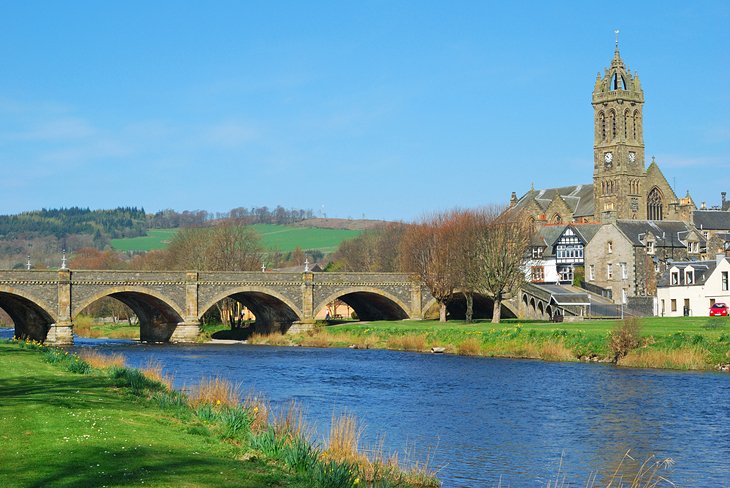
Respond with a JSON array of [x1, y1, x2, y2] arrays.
[[312, 286, 412, 320]]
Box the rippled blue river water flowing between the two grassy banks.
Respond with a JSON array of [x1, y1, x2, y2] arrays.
[[2, 330, 730, 487]]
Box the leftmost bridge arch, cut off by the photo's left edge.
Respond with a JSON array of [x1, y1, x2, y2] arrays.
[[0, 286, 58, 342]]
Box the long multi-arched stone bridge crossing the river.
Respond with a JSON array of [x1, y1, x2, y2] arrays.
[[0, 269, 434, 344]]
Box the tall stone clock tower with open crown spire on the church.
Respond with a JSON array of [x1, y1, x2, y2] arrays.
[[592, 37, 647, 222]]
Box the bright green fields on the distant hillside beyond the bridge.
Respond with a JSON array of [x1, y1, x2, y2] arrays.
[[112, 224, 362, 254]]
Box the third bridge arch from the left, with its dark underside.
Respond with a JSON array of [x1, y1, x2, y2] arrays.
[[197, 285, 304, 333]]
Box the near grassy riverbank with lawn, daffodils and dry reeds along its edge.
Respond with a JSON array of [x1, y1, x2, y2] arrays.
[[0, 341, 437, 487]]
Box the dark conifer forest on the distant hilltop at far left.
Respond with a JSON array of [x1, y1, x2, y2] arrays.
[[0, 207, 147, 239]]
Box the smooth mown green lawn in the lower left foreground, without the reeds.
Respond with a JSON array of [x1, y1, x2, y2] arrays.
[[0, 343, 308, 488]]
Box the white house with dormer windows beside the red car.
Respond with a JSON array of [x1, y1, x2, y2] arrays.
[[656, 254, 730, 317]]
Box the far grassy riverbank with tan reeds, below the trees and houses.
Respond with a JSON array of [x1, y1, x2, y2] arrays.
[[252, 317, 730, 370]]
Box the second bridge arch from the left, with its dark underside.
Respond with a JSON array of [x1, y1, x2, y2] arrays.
[[71, 286, 185, 342]]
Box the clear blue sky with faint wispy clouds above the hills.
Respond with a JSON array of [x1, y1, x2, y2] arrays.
[[0, 0, 730, 220]]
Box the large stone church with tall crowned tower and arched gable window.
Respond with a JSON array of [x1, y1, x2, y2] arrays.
[[510, 42, 696, 224]]
